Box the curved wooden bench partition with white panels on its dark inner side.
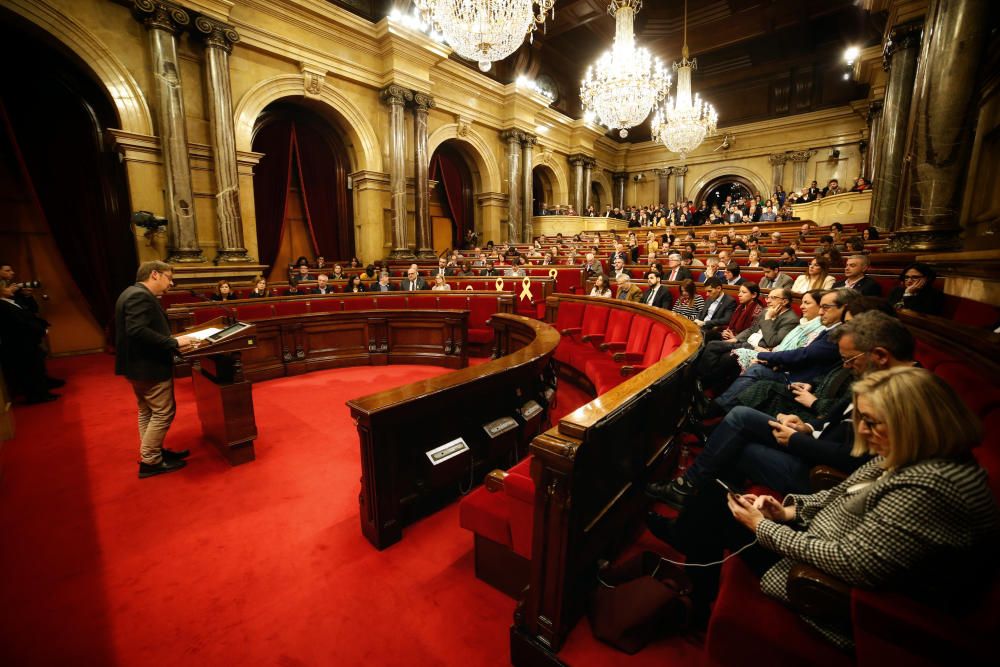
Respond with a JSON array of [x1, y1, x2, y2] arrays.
[[347, 314, 559, 549]]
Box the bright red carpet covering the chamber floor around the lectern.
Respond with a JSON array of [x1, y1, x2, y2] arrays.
[[0, 355, 704, 667]]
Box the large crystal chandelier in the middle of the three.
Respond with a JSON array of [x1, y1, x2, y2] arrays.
[[580, 0, 670, 139]]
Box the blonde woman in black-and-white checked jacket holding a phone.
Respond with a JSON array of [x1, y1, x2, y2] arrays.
[[656, 367, 1000, 649]]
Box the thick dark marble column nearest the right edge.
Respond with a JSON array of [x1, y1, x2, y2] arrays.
[[893, 0, 994, 251]]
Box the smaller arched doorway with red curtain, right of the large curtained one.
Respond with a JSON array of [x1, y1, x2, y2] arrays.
[[429, 139, 476, 254]]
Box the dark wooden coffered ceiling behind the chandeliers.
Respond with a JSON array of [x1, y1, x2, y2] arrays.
[[330, 0, 885, 141]]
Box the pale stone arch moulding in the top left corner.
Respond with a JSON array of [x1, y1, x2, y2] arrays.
[[4, 0, 153, 136]]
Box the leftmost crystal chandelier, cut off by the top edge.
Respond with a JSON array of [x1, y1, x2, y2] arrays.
[[414, 0, 556, 72]]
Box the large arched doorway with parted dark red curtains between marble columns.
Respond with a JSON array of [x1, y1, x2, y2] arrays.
[[253, 100, 355, 278]]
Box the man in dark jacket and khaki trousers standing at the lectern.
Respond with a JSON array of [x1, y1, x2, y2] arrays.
[[115, 260, 198, 479]]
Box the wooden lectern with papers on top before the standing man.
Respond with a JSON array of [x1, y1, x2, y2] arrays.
[[179, 317, 257, 466]]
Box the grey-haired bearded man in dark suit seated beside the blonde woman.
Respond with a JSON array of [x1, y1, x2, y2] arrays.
[[646, 311, 916, 507]]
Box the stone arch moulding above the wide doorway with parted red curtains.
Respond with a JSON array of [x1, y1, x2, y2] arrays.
[[234, 74, 383, 172]]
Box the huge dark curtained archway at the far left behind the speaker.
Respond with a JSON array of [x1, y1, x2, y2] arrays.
[[0, 13, 138, 352]]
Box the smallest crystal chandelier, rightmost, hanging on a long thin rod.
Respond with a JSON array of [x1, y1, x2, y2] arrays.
[[652, 0, 719, 160]]
